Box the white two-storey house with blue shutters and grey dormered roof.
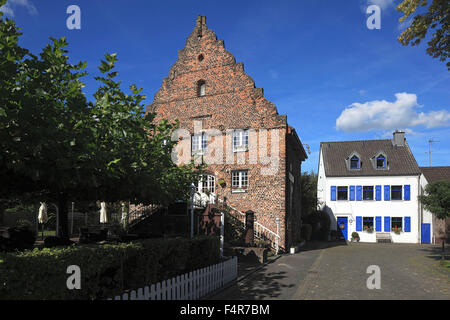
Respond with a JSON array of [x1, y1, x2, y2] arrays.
[[317, 131, 433, 243]]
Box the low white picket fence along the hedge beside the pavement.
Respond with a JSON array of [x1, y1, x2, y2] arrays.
[[108, 257, 237, 300]]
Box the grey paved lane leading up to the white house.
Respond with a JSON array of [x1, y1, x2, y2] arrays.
[[209, 243, 450, 300]]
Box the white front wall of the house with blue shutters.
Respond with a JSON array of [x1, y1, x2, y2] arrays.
[[317, 153, 424, 243]]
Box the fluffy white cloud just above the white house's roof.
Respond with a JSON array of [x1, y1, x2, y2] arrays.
[[336, 92, 450, 132]]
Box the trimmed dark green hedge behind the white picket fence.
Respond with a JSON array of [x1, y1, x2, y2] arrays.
[[0, 237, 220, 300]]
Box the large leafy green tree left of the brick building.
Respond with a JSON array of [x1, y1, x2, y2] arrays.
[[0, 8, 200, 237]]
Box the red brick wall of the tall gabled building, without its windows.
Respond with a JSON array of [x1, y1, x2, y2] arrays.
[[147, 17, 301, 249]]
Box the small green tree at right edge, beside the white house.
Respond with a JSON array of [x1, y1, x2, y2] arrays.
[[419, 180, 450, 258]]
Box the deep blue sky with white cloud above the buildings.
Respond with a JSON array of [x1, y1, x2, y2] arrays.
[[3, 0, 450, 171]]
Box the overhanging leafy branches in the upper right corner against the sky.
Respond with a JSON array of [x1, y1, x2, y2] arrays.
[[397, 0, 450, 70]]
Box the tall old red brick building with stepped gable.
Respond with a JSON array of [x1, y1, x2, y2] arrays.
[[147, 16, 307, 247]]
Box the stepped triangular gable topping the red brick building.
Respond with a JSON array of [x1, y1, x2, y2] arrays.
[[147, 16, 287, 130]]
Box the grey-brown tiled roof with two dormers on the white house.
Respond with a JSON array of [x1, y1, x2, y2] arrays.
[[320, 139, 421, 177]]
